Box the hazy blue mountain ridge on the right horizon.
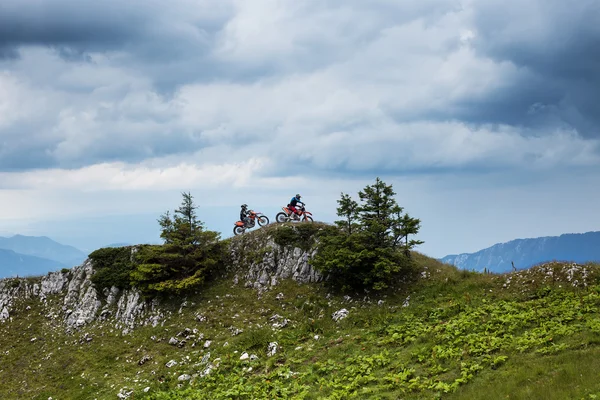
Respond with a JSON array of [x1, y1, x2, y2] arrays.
[[440, 232, 600, 273]]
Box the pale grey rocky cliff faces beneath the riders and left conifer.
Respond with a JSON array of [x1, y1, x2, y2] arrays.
[[0, 236, 322, 334]]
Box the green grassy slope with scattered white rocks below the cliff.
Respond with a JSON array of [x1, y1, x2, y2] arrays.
[[0, 254, 600, 400]]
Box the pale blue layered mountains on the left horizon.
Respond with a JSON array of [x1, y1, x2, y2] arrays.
[[0, 235, 87, 278]]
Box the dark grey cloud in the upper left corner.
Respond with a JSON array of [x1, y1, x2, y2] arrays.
[[0, 0, 228, 67]]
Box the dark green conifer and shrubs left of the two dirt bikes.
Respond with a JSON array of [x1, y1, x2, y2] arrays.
[[89, 193, 227, 296]]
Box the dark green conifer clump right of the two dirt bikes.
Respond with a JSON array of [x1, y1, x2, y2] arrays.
[[312, 178, 423, 290]]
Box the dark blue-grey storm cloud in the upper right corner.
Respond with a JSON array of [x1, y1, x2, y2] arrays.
[[464, 0, 600, 138]]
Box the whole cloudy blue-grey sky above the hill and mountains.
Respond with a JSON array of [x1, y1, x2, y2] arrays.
[[0, 0, 600, 257]]
